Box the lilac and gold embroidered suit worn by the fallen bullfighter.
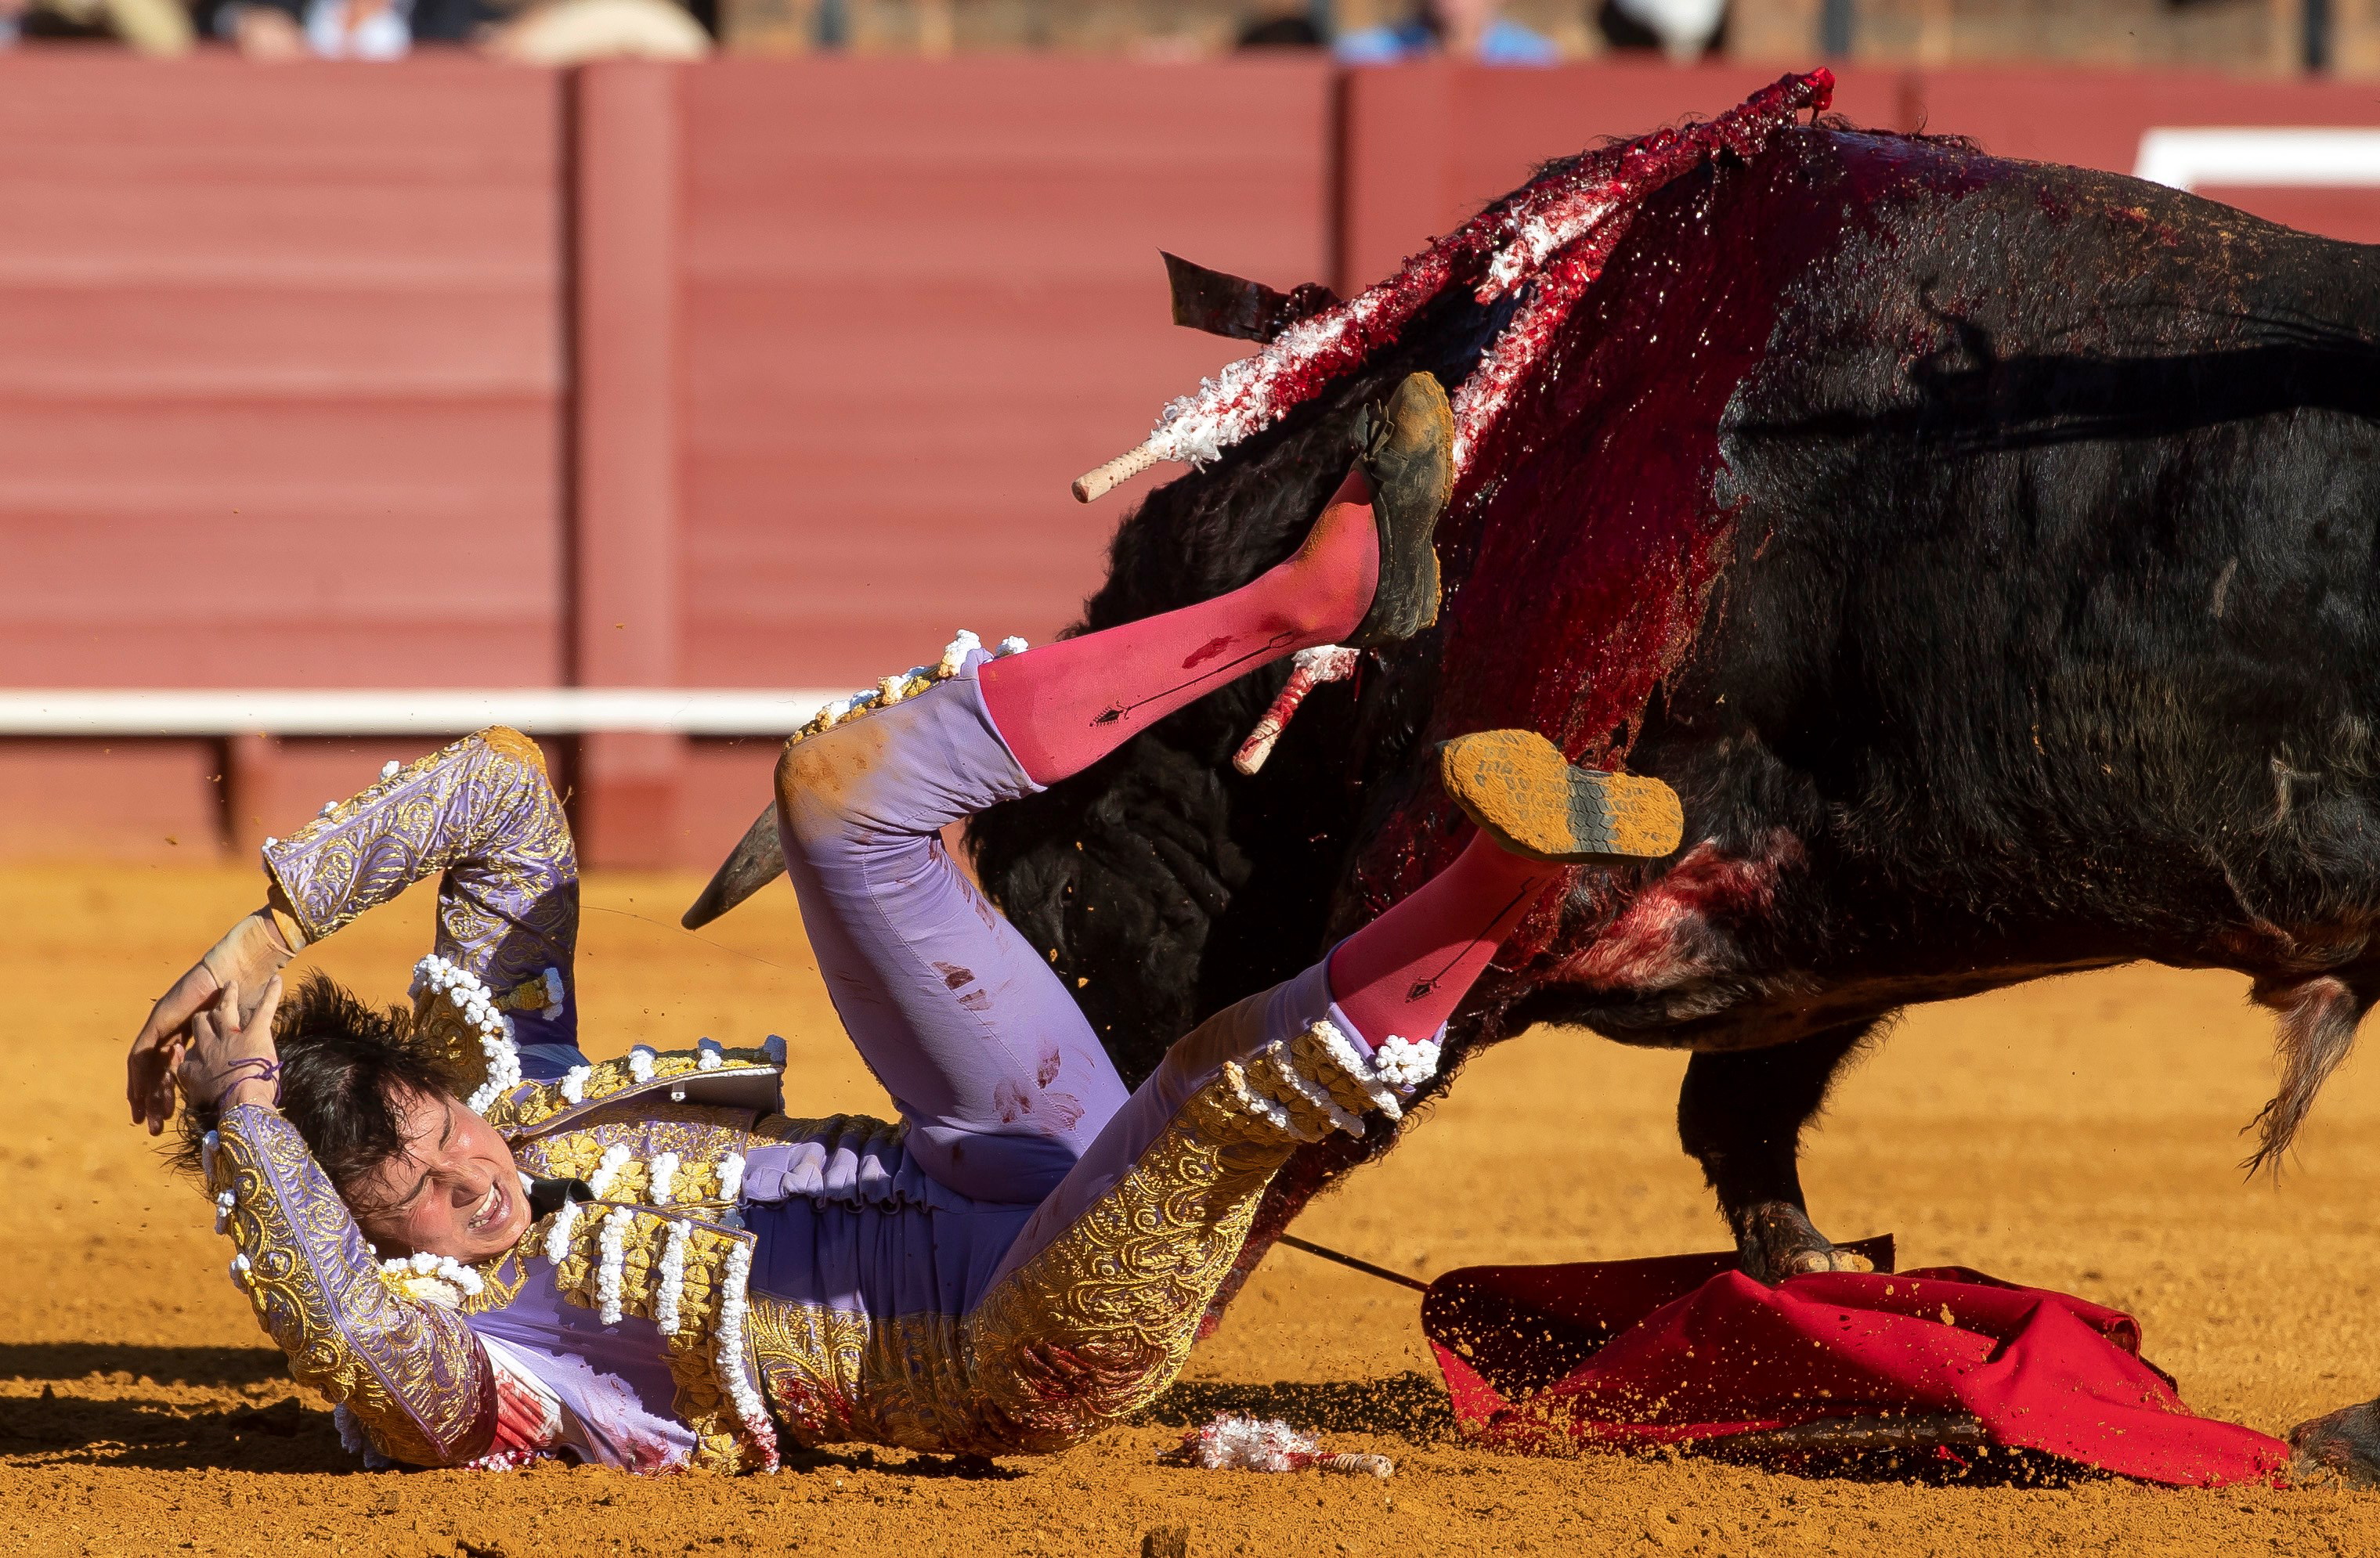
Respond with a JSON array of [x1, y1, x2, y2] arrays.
[[209, 657, 1395, 1470]]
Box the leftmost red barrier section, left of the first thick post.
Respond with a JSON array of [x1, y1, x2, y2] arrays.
[[0, 52, 564, 857]]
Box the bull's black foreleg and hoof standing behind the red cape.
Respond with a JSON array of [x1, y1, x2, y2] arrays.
[[1678, 1018, 1876, 1282]]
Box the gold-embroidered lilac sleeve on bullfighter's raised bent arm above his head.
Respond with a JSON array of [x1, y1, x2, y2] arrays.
[[264, 726, 578, 1022]]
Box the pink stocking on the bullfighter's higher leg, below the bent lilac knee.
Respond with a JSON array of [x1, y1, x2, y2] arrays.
[[981, 471, 1381, 785]]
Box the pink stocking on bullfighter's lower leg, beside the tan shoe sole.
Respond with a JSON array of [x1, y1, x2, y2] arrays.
[[1331, 832, 1564, 1044]]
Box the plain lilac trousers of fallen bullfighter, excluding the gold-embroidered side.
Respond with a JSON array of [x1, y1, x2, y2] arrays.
[[745, 654, 1354, 1315]]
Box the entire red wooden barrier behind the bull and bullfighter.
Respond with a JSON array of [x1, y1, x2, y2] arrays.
[[0, 55, 2380, 864]]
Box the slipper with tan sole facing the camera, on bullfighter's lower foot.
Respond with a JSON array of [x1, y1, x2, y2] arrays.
[[1438, 730, 1685, 861]]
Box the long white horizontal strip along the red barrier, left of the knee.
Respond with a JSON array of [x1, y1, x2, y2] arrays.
[[0, 687, 843, 735]]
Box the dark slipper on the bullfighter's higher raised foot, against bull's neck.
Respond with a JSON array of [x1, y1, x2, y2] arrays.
[[1347, 373, 1454, 649]]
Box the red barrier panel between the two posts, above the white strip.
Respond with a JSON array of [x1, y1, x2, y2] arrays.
[[681, 60, 1331, 685]]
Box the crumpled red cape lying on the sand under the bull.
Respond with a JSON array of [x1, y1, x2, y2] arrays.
[[1421, 1237, 2290, 1487]]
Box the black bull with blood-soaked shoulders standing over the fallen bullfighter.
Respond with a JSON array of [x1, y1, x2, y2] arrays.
[[973, 116, 2380, 1369]]
